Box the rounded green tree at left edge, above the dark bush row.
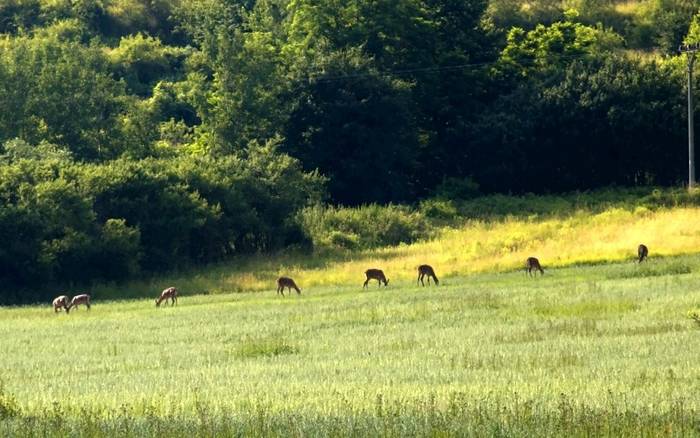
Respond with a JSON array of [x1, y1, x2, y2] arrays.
[[0, 35, 124, 159]]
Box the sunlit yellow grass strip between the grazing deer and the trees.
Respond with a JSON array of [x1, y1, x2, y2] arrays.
[[93, 207, 700, 299]]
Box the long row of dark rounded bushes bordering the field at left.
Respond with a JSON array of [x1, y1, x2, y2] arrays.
[[0, 141, 323, 302]]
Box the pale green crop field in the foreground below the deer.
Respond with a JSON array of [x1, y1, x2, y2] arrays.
[[0, 252, 700, 437]]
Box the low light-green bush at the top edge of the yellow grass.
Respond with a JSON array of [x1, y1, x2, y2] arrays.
[[299, 204, 432, 249]]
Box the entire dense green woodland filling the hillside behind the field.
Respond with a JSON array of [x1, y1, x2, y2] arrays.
[[0, 0, 700, 302]]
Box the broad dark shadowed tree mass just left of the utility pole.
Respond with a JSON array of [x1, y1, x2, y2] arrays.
[[476, 52, 684, 192]]
